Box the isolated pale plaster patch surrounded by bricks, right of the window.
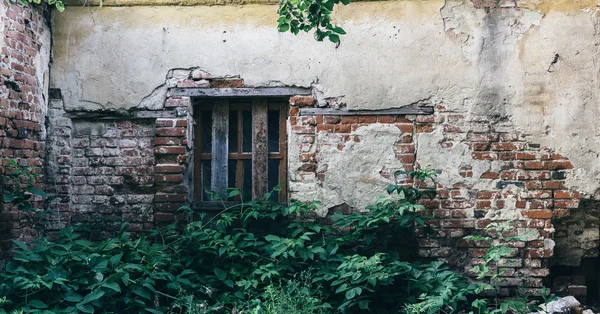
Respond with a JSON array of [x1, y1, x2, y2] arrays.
[[289, 123, 403, 215]]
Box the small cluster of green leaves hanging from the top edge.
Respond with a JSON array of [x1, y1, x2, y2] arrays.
[[277, 0, 350, 43]]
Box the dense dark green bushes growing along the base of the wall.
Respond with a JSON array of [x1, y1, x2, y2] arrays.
[[0, 164, 552, 314]]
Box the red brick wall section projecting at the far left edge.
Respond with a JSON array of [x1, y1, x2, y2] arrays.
[[0, 0, 50, 259]]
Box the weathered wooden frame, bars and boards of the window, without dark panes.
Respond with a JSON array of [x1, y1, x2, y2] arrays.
[[194, 95, 289, 210]]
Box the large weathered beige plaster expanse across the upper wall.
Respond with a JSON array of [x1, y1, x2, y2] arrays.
[[51, 0, 600, 197]]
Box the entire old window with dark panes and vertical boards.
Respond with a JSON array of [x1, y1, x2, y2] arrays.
[[194, 98, 287, 202]]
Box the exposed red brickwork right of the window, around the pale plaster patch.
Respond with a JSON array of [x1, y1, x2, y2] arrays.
[[289, 97, 584, 295]]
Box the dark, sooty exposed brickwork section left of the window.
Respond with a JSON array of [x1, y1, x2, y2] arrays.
[[46, 93, 189, 236]]
